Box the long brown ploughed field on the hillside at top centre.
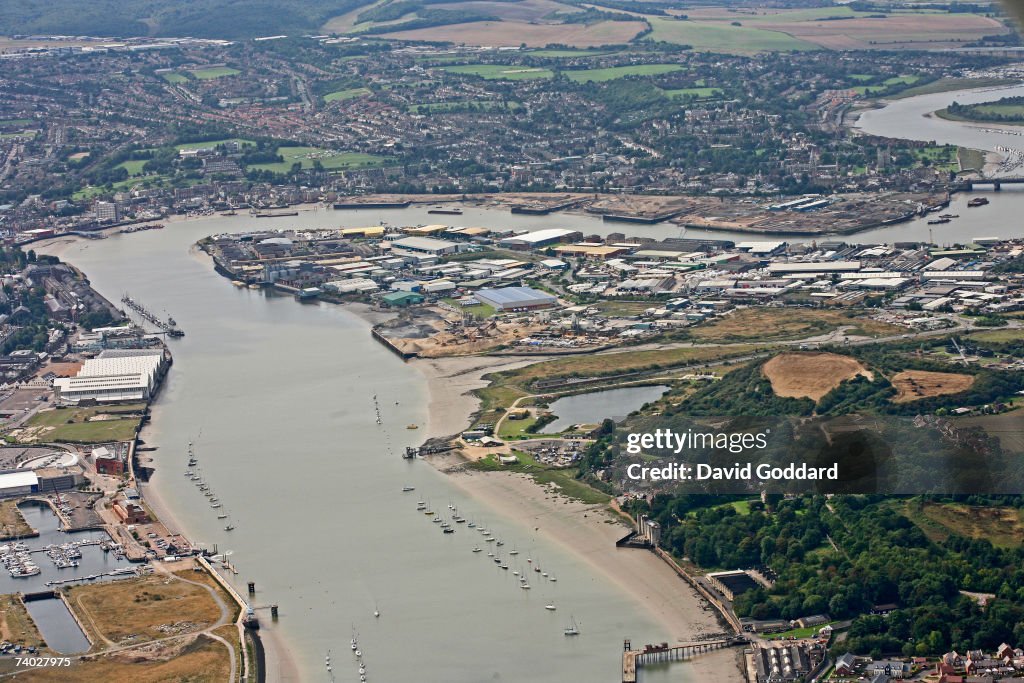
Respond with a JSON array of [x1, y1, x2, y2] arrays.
[[382, 22, 647, 47]]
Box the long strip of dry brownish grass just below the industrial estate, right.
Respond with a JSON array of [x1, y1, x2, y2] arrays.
[[692, 308, 903, 342]]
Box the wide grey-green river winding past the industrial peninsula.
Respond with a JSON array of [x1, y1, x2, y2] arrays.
[[29, 81, 1024, 683]]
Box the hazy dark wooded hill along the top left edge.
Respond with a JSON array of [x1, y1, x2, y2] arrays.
[[0, 0, 374, 39]]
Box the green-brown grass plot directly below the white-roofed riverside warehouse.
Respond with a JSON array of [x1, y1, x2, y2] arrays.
[[18, 403, 145, 443]]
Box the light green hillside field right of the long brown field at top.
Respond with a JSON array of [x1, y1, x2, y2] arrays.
[[648, 16, 821, 54]]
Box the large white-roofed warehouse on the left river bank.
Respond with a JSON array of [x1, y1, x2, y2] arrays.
[[53, 349, 169, 404]]
